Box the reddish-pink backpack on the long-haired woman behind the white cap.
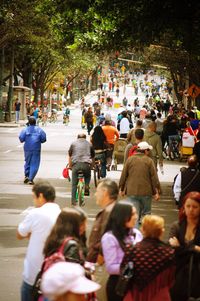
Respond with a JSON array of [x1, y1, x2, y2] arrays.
[[32, 237, 73, 301]]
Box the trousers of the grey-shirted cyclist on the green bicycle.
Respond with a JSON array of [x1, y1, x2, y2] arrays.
[[71, 162, 91, 202]]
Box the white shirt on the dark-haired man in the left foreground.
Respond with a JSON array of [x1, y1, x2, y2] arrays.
[[18, 202, 60, 285]]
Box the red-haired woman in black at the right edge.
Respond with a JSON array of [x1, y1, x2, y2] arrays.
[[169, 191, 200, 301]]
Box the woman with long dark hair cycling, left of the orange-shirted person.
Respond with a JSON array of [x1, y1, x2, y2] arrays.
[[91, 125, 107, 178]]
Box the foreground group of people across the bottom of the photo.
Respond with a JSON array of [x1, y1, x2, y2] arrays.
[[17, 178, 200, 301]]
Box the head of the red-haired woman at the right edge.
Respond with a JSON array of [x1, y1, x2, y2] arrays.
[[179, 191, 200, 224]]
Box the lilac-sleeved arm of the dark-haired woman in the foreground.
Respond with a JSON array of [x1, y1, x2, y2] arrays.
[[101, 233, 123, 275]]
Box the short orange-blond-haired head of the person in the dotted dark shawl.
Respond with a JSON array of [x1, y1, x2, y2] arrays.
[[141, 215, 165, 239]]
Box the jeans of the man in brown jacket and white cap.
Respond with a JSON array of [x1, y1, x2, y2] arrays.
[[128, 195, 152, 228]]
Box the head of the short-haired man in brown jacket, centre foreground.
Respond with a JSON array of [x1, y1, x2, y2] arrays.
[[95, 179, 119, 208]]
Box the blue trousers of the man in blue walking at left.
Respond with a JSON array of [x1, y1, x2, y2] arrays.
[[24, 151, 40, 181]]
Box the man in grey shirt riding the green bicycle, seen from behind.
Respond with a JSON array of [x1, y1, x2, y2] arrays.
[[68, 134, 95, 206]]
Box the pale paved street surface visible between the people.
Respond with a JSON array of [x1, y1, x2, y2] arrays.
[[0, 86, 186, 301]]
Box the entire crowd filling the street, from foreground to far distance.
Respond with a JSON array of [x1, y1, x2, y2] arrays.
[[17, 72, 200, 301]]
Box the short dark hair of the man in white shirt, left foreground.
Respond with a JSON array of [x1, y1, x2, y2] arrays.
[[32, 180, 56, 202]]
